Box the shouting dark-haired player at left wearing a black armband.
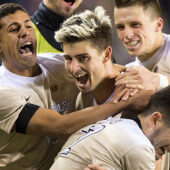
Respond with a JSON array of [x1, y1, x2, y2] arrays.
[[0, 3, 141, 170]]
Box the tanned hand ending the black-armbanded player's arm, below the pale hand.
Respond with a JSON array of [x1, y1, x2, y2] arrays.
[[127, 90, 154, 111]]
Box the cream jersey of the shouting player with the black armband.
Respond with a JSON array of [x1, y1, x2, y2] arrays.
[[0, 54, 78, 170]]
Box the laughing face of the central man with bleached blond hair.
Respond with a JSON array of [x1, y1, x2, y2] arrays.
[[63, 40, 105, 93]]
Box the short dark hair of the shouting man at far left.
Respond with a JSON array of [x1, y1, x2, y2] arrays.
[[0, 3, 28, 19]]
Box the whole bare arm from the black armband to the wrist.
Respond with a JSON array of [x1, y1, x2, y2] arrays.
[[26, 102, 127, 138]]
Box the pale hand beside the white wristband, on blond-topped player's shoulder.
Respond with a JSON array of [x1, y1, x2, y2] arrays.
[[115, 66, 160, 90]]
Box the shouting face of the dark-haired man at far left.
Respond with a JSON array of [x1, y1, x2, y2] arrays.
[[0, 10, 36, 73]]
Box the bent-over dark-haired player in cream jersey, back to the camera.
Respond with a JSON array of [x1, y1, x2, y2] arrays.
[[50, 86, 170, 170]]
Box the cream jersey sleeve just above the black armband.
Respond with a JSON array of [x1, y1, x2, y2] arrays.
[[0, 87, 26, 133]]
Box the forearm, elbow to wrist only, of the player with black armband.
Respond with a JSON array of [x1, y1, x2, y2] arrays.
[[58, 102, 127, 135]]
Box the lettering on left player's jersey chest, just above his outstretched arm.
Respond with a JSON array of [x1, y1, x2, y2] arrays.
[[50, 97, 71, 114]]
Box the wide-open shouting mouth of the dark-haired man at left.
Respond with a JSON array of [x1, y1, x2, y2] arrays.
[[19, 41, 34, 57]]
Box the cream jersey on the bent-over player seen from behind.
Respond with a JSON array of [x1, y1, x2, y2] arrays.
[[50, 118, 155, 170]]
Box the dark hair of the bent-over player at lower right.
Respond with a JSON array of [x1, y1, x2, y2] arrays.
[[142, 86, 170, 127]]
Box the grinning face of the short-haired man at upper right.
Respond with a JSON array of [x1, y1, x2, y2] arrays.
[[114, 5, 163, 60]]
